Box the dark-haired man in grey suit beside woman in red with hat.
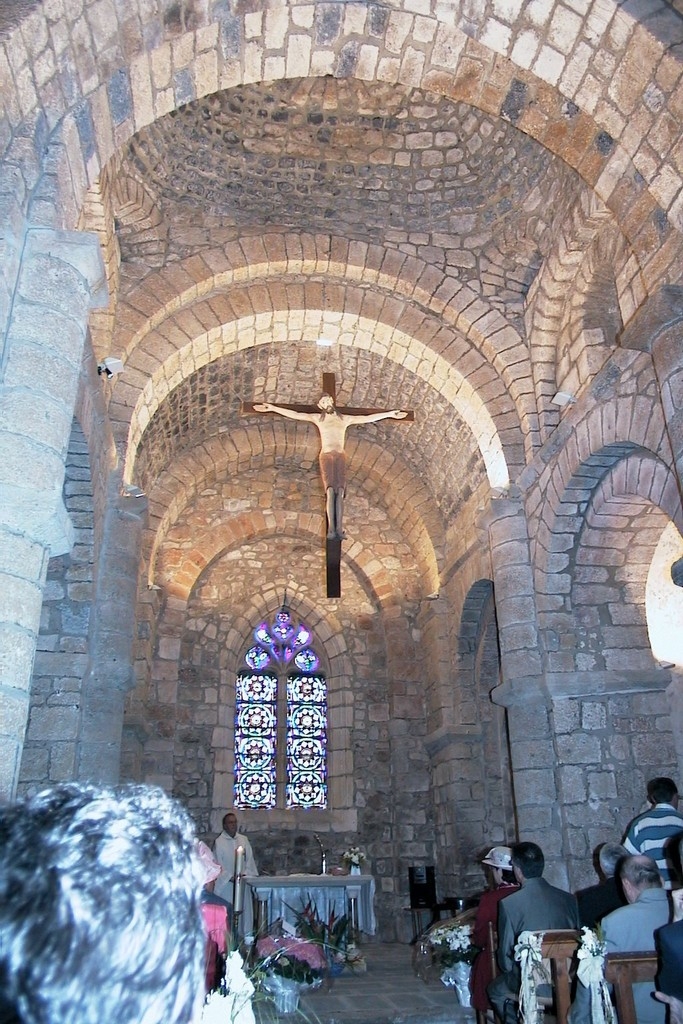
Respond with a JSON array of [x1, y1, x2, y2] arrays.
[[486, 843, 579, 1024]]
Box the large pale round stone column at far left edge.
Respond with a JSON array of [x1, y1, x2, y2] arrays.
[[0, 228, 106, 798]]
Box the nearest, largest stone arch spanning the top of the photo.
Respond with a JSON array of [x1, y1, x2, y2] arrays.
[[6, 2, 681, 244]]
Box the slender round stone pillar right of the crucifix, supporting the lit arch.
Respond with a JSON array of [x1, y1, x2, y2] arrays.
[[485, 497, 568, 888]]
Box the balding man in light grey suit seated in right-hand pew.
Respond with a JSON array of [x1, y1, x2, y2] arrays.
[[602, 856, 669, 1024]]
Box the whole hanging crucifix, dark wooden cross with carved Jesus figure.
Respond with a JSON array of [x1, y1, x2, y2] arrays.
[[242, 374, 415, 597]]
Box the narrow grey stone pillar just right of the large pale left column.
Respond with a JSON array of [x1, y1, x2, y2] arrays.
[[77, 472, 147, 784]]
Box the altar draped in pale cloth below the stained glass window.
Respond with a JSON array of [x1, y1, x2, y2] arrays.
[[245, 874, 377, 935]]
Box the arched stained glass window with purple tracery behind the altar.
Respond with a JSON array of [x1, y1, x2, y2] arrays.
[[234, 607, 328, 807]]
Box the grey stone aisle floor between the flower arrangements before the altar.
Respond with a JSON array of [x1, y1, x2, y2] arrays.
[[254, 943, 474, 1024]]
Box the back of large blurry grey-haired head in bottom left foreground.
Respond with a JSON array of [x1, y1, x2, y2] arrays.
[[0, 783, 205, 1024]]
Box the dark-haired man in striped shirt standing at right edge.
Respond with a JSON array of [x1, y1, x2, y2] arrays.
[[624, 777, 683, 889]]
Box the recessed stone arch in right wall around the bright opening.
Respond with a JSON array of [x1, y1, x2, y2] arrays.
[[538, 442, 683, 682]]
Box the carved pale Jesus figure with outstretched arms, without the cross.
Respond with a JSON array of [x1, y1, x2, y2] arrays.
[[252, 394, 409, 540]]
